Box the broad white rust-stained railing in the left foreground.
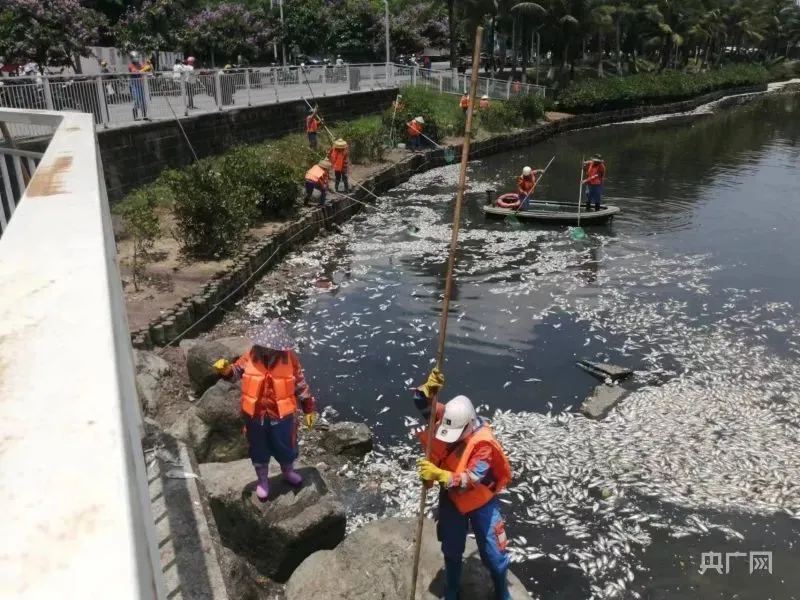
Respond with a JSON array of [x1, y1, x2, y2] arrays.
[[0, 109, 166, 600]]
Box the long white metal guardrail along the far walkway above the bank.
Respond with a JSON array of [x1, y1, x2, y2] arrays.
[[0, 63, 546, 137]]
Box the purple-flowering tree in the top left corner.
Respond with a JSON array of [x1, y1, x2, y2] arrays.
[[0, 0, 105, 66]]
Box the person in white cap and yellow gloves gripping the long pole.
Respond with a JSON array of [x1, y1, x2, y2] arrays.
[[414, 369, 511, 600]]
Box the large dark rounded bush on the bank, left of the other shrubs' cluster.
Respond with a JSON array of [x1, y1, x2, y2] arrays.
[[167, 164, 258, 259]]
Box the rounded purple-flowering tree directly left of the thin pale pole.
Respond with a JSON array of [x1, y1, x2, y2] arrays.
[[183, 3, 268, 59]]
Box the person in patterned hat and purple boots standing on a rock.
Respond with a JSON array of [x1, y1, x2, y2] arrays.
[[214, 319, 317, 502]]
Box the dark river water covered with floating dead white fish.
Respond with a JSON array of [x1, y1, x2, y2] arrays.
[[245, 97, 800, 599]]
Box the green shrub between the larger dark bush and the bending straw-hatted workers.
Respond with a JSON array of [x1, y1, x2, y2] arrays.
[[218, 145, 298, 219]]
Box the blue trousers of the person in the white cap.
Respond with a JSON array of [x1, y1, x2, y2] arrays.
[[437, 490, 511, 600]]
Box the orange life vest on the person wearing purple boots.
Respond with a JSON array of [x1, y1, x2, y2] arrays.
[[241, 352, 299, 419]]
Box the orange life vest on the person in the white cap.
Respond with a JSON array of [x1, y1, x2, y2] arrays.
[[417, 422, 512, 515]]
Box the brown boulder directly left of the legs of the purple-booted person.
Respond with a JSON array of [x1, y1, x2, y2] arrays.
[[194, 379, 247, 462]]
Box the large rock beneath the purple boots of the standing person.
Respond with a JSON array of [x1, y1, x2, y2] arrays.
[[200, 460, 346, 581]]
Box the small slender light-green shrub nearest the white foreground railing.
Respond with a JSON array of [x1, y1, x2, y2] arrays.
[[114, 187, 161, 291]]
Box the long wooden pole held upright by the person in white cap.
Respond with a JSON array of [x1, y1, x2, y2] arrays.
[[409, 27, 483, 600]]
